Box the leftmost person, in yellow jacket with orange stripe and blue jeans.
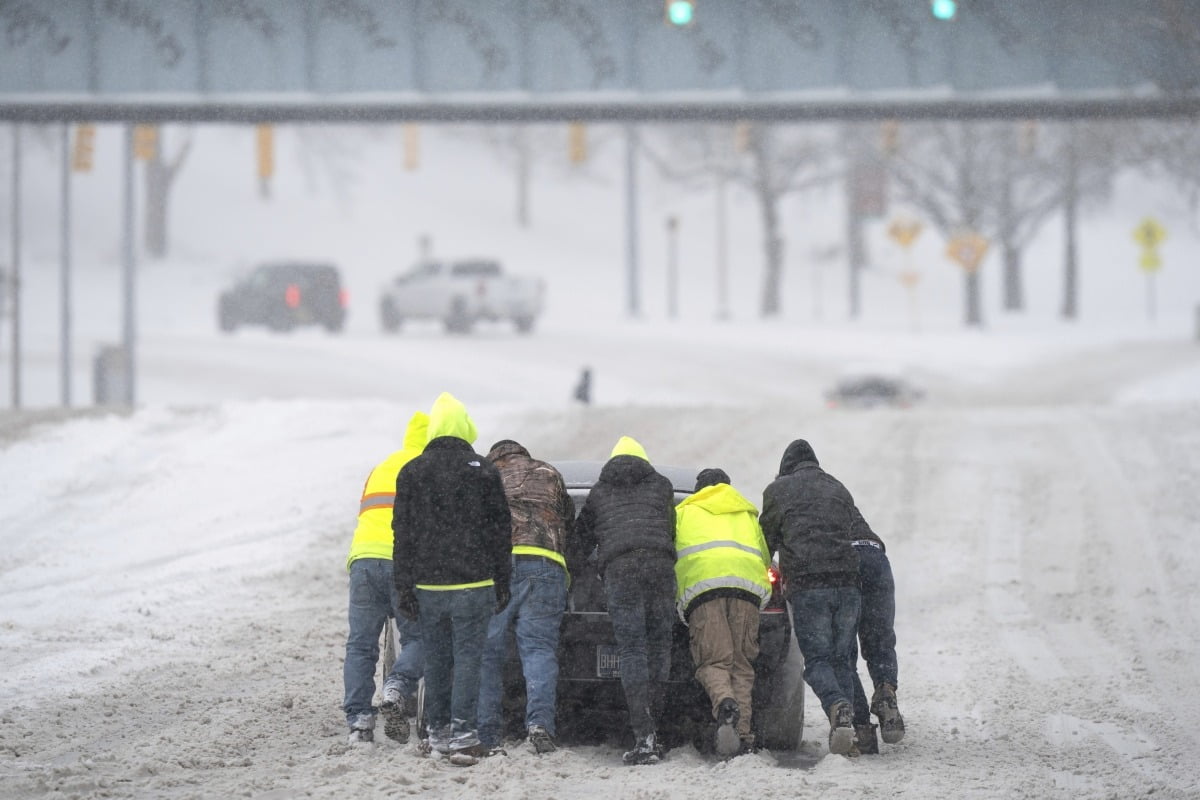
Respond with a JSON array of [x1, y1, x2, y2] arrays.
[[342, 411, 430, 742]]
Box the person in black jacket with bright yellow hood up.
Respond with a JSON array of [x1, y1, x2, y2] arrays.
[[392, 392, 511, 756]]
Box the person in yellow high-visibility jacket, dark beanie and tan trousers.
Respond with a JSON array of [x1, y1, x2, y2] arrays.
[[676, 469, 770, 758]]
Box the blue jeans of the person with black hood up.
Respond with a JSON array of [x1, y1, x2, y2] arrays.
[[788, 587, 860, 717]]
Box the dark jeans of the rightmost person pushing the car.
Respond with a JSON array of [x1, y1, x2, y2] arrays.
[[850, 545, 899, 724]]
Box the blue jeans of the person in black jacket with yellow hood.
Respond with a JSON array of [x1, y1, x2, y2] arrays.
[[416, 585, 496, 736]]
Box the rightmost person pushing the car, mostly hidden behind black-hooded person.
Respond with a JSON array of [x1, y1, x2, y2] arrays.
[[850, 507, 904, 754]]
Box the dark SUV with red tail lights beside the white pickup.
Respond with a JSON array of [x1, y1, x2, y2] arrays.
[[217, 261, 346, 332]]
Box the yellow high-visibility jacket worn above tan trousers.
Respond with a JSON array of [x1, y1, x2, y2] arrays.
[[676, 483, 770, 616]]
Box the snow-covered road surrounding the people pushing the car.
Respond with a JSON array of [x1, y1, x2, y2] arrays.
[[0, 326, 1200, 800]]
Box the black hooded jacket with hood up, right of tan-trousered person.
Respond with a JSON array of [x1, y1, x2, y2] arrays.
[[760, 439, 858, 591]]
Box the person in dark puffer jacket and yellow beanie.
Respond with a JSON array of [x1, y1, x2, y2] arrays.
[[575, 437, 676, 764]]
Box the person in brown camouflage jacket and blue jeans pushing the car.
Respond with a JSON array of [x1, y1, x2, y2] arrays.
[[479, 439, 575, 753]]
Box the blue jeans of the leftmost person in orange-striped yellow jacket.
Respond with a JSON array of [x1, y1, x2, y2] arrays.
[[342, 559, 425, 726]]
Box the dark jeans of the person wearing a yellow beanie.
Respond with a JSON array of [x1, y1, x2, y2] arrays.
[[604, 552, 676, 739]]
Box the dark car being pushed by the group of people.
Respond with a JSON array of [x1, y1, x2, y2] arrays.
[[492, 461, 804, 752]]
